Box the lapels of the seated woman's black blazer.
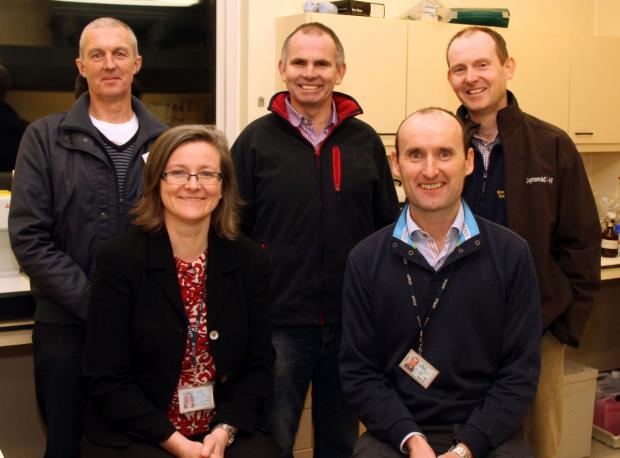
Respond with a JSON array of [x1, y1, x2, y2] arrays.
[[146, 229, 239, 324]]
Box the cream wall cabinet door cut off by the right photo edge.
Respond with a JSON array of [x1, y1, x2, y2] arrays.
[[569, 36, 620, 151]]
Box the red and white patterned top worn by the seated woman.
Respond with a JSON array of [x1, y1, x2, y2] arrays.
[[168, 251, 215, 436]]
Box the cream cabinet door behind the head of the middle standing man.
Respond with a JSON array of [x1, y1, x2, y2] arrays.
[[276, 14, 407, 134]]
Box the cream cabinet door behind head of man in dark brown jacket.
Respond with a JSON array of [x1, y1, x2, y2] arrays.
[[407, 21, 569, 129]]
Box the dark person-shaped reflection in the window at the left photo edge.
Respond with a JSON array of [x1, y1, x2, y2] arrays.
[[0, 64, 28, 172]]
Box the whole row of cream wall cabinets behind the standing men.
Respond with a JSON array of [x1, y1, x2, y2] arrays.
[[276, 13, 620, 152]]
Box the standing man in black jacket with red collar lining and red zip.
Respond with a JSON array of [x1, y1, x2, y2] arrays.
[[233, 23, 398, 458]]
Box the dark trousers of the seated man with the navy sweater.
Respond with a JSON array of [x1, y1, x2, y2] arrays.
[[353, 425, 535, 458]]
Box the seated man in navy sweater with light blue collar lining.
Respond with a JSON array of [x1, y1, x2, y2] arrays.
[[341, 108, 540, 458]]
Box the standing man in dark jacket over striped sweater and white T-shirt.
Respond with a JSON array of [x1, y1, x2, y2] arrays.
[[9, 18, 165, 458]]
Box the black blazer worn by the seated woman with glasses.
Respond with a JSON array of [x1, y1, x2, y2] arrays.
[[84, 228, 274, 446]]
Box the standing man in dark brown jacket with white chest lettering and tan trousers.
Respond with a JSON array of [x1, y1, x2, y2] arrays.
[[446, 27, 601, 458]]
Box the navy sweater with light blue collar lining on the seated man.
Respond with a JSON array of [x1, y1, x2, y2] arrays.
[[341, 207, 540, 458]]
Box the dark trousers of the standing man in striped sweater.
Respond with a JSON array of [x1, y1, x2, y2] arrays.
[[32, 323, 88, 458]]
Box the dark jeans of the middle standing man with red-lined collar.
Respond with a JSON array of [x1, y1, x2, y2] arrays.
[[267, 325, 359, 458]]
